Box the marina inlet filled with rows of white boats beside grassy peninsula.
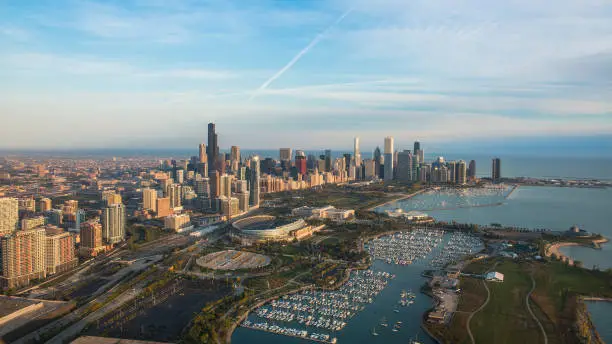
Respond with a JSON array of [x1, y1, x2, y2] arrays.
[[241, 228, 482, 343]]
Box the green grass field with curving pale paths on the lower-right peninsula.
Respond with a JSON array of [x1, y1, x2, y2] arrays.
[[430, 259, 612, 344]]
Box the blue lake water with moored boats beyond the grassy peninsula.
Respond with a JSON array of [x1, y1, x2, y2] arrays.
[[376, 186, 612, 236]]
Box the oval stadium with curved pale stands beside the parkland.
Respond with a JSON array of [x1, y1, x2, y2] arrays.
[[232, 215, 313, 244]]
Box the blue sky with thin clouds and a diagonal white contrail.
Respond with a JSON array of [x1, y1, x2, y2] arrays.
[[0, 0, 612, 149]]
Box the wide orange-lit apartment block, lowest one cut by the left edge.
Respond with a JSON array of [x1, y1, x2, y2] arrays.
[[0, 227, 46, 288]]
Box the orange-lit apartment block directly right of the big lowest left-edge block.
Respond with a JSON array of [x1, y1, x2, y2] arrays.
[[45, 228, 79, 275]]
